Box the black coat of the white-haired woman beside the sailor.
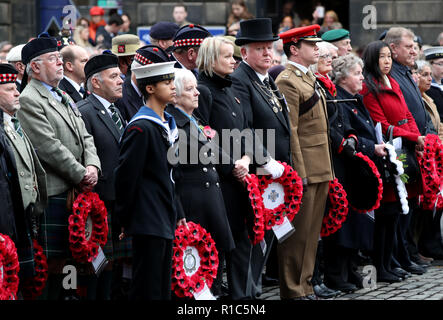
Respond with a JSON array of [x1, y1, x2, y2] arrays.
[[166, 106, 234, 251]]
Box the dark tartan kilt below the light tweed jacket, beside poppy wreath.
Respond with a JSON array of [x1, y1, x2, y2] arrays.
[[39, 192, 72, 259]]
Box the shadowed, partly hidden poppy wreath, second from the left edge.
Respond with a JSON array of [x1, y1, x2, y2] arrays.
[[22, 239, 48, 300]]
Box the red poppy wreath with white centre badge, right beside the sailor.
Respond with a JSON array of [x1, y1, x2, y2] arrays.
[[171, 221, 219, 298]]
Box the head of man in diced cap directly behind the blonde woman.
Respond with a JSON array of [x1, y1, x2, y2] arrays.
[[171, 24, 211, 78]]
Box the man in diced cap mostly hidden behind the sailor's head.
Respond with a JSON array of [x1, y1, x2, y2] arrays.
[[115, 45, 169, 122]]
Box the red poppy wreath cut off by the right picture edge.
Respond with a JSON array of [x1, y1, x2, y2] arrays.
[[419, 134, 443, 210]]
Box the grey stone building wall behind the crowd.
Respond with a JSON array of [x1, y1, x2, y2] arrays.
[[0, 0, 443, 46]]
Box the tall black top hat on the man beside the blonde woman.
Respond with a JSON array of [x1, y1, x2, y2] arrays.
[[235, 18, 279, 46]]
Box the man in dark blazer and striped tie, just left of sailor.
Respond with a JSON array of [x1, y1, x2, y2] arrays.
[[78, 53, 126, 300]]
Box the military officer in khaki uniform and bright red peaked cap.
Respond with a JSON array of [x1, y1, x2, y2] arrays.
[[276, 25, 333, 300]]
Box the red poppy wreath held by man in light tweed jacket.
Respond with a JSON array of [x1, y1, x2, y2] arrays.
[[69, 192, 108, 263]]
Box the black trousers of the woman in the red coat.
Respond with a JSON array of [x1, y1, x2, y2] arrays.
[[373, 202, 401, 274]]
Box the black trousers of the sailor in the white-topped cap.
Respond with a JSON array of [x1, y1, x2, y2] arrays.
[[129, 235, 172, 300]]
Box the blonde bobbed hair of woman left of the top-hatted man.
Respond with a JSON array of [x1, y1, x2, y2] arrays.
[[196, 36, 234, 77]]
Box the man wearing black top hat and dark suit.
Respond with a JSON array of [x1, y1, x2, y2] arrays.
[[232, 18, 291, 294]]
